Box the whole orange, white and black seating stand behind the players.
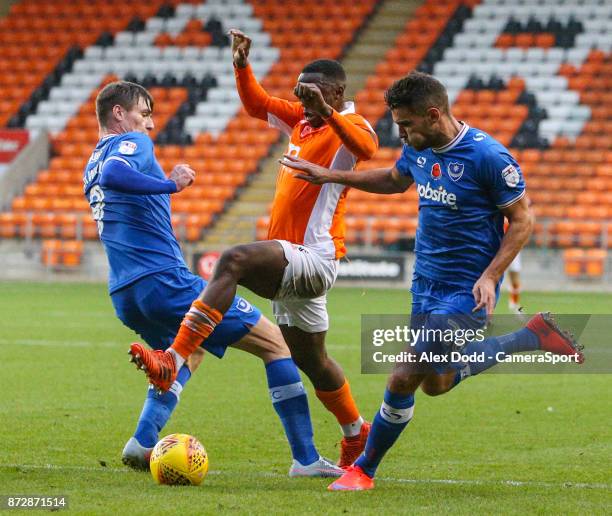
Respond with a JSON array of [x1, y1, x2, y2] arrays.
[[0, 0, 612, 277]]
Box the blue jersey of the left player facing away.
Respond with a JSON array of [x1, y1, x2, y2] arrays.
[[83, 132, 187, 294]]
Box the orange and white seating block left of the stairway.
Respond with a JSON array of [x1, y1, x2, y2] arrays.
[[0, 1, 374, 254]]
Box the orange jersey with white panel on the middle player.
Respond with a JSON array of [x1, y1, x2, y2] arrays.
[[236, 63, 378, 259]]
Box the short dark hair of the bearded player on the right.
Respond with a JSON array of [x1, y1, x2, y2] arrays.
[[385, 72, 450, 114]]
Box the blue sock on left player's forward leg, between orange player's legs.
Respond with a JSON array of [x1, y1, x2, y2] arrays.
[[266, 358, 319, 466]]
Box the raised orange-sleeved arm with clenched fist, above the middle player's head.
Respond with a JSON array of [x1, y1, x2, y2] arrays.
[[229, 29, 304, 127]]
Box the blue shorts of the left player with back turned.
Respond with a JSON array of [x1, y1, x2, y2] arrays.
[[111, 267, 261, 358]]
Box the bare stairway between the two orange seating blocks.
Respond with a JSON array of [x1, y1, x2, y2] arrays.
[[202, 0, 422, 248]]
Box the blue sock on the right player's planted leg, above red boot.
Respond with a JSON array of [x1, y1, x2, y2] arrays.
[[355, 389, 414, 477]]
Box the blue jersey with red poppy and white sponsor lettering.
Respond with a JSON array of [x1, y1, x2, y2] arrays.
[[395, 124, 525, 290]]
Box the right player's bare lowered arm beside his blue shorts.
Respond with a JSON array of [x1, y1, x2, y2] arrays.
[[472, 196, 534, 315]]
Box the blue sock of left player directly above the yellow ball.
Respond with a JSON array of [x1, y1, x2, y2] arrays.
[[134, 365, 191, 448]]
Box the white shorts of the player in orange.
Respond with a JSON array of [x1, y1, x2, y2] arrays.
[[272, 240, 338, 333]]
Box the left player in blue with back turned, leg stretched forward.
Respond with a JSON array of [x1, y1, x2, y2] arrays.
[[84, 81, 342, 477]]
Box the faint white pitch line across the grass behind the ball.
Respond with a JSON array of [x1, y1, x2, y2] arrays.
[[0, 464, 612, 490]]
